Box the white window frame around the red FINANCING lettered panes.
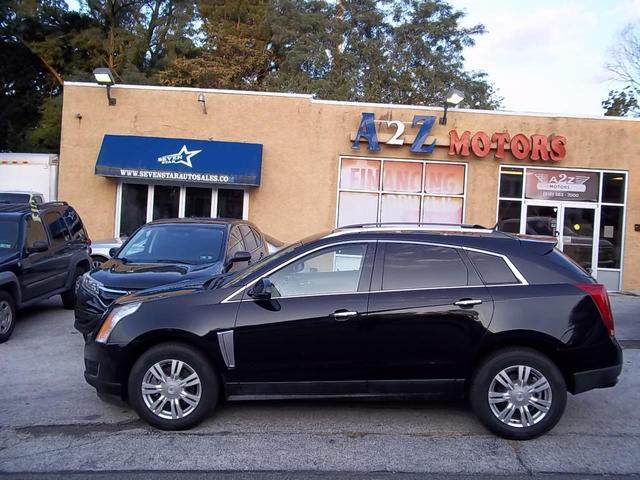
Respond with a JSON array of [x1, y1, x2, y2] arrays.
[[334, 155, 469, 228]]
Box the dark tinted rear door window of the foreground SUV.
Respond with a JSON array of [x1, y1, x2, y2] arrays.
[[382, 243, 467, 290]]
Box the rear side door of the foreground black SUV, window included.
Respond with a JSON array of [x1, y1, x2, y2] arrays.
[[365, 242, 493, 393]]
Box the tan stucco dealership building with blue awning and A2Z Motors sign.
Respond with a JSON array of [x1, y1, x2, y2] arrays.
[[59, 82, 640, 290]]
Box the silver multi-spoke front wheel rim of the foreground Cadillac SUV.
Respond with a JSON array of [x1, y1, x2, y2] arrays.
[[141, 359, 202, 420]]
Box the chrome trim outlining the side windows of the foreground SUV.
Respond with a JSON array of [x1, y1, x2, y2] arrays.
[[220, 239, 529, 303]]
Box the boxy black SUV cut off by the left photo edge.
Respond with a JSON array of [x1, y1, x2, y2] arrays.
[[0, 202, 91, 343]]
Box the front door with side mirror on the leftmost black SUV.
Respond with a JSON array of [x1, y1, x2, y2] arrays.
[[20, 215, 56, 301]]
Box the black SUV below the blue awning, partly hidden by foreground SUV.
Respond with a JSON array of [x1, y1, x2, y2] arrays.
[[75, 218, 268, 335]]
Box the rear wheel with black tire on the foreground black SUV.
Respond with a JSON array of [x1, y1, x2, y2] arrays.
[[469, 347, 567, 440]]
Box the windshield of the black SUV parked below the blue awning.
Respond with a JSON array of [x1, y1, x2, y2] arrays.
[[116, 224, 225, 264]]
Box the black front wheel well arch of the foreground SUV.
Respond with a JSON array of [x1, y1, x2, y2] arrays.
[[120, 331, 225, 400]]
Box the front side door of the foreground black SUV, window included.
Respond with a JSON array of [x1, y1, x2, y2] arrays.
[[235, 242, 375, 395]]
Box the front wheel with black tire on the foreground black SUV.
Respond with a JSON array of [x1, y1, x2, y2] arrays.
[[128, 343, 219, 430]]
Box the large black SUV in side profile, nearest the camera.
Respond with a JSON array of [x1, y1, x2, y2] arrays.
[[85, 226, 622, 439]]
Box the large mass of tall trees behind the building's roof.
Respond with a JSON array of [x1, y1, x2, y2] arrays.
[[0, 0, 500, 152]]
